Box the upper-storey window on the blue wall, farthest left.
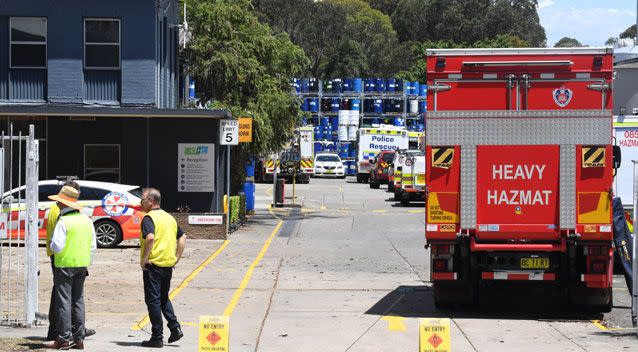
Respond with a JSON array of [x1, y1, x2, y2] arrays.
[[9, 17, 47, 68]]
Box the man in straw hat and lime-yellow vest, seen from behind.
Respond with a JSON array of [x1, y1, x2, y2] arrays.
[[46, 186, 97, 350]]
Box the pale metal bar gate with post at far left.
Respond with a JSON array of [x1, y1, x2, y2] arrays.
[[0, 124, 39, 326]]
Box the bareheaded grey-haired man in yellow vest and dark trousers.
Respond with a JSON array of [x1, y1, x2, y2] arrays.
[[140, 188, 186, 347]]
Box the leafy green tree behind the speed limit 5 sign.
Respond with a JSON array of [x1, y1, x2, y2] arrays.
[[183, 0, 308, 190]]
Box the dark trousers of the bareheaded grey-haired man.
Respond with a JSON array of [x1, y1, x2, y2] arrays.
[[143, 264, 180, 340]]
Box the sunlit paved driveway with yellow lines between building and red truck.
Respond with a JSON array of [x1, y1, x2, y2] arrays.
[[0, 178, 638, 352]]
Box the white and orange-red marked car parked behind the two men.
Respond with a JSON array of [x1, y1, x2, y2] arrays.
[[2, 180, 144, 247]]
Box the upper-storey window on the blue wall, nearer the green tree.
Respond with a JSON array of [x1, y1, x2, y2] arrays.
[[84, 18, 121, 70]]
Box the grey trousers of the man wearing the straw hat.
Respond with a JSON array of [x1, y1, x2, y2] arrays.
[[53, 268, 86, 341]]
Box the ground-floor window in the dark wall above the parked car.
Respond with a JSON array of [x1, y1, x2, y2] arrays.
[[84, 144, 120, 183]]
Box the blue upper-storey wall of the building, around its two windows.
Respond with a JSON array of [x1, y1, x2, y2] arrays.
[[0, 0, 179, 107]]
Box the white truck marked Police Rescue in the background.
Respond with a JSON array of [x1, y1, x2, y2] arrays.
[[357, 126, 408, 183]]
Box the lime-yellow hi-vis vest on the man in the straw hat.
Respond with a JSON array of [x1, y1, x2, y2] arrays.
[[53, 212, 93, 268]]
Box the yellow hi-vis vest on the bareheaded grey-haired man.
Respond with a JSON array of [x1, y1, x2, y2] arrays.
[[140, 209, 177, 268]]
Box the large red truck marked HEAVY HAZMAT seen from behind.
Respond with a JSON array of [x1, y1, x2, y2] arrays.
[[425, 48, 620, 311]]
